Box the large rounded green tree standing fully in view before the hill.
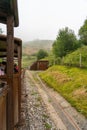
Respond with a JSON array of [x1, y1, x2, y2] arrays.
[[53, 27, 78, 57]]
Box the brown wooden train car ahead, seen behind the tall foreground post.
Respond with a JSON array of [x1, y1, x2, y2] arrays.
[[0, 35, 22, 130]]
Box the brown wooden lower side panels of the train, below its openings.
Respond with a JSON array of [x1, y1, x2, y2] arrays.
[[0, 74, 21, 130]]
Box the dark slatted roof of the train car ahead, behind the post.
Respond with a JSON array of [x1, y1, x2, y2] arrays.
[[0, 35, 22, 57]]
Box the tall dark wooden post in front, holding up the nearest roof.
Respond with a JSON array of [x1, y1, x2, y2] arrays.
[[7, 16, 14, 130]]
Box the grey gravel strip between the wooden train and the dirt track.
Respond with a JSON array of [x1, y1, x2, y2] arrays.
[[19, 70, 57, 130]]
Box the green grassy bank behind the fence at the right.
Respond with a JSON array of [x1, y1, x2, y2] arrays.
[[39, 46, 87, 68]]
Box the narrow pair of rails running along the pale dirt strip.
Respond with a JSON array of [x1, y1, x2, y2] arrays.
[[38, 77, 81, 130]]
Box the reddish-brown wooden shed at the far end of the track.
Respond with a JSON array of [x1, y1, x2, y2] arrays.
[[30, 60, 49, 70]]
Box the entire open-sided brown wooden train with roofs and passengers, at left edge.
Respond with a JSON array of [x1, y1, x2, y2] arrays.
[[0, 0, 22, 130]]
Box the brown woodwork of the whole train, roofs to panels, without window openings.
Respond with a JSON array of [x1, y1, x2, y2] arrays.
[[0, 0, 22, 130]]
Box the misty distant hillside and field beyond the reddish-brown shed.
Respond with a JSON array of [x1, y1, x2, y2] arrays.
[[22, 40, 53, 67]]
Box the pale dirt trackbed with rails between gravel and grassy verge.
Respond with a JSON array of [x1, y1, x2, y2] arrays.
[[29, 71, 87, 130]]
